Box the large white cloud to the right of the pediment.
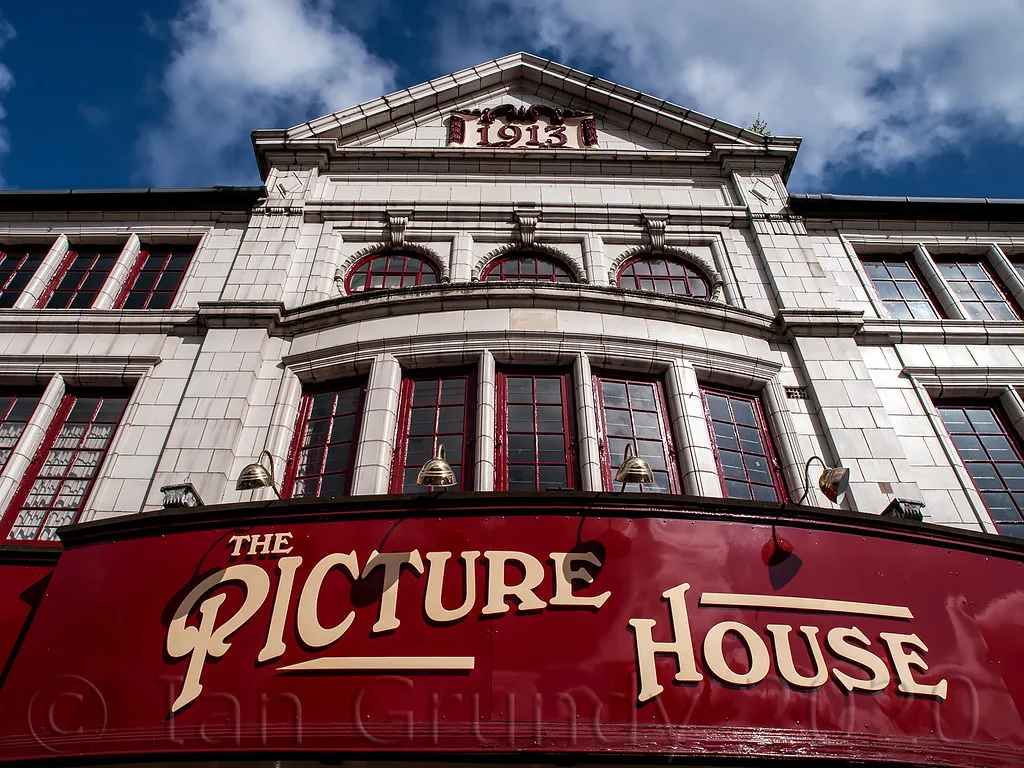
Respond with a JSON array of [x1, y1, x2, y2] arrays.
[[443, 0, 1024, 186]]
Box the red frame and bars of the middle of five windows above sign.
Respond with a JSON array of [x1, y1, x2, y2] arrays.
[[495, 369, 580, 490]]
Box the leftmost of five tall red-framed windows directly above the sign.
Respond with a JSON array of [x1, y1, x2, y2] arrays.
[[283, 381, 366, 498]]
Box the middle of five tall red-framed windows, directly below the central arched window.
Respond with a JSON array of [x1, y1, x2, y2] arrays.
[[495, 373, 578, 490]]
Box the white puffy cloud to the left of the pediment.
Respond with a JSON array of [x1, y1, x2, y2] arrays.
[[138, 0, 394, 185]]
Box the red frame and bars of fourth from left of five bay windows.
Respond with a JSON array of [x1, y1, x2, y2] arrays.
[[594, 374, 680, 494]]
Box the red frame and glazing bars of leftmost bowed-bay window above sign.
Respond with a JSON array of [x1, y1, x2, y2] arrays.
[[281, 379, 367, 499]]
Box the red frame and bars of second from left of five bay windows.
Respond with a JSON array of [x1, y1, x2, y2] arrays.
[[390, 370, 476, 494]]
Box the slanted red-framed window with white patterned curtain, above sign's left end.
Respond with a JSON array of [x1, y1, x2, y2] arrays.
[[7, 392, 128, 541]]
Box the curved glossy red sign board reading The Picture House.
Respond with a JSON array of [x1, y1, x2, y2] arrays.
[[0, 497, 1024, 766]]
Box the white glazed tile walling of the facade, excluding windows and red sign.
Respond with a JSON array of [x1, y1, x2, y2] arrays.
[[0, 56, 1024, 532]]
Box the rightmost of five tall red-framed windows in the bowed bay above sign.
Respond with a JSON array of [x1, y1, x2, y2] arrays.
[[703, 389, 785, 502]]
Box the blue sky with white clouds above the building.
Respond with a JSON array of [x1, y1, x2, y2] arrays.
[[0, 0, 1024, 198]]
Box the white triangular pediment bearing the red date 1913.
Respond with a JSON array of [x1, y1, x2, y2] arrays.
[[253, 53, 800, 176]]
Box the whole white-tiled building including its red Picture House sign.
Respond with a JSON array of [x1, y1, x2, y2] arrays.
[[0, 54, 1024, 766]]
